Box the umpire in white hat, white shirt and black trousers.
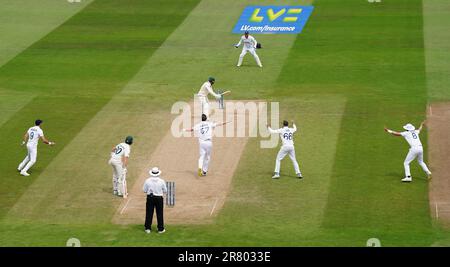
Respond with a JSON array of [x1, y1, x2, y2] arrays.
[[143, 167, 167, 234]]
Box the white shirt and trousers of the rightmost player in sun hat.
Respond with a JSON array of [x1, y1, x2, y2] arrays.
[[400, 130, 431, 177]]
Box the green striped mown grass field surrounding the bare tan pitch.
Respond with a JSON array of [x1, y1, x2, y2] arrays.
[[0, 0, 450, 246]]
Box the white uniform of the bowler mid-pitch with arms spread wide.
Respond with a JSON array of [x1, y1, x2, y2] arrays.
[[193, 121, 217, 172]]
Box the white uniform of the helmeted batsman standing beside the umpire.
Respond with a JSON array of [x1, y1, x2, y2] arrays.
[[108, 143, 131, 196]]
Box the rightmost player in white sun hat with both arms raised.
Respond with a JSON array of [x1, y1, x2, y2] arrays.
[[384, 121, 431, 182]]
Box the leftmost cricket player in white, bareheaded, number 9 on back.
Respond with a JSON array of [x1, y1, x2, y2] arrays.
[[17, 120, 55, 176]]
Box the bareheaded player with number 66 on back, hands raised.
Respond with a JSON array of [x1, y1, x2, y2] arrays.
[[267, 121, 303, 179]]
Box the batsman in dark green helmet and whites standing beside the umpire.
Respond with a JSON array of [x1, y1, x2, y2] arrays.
[[108, 136, 133, 198]]
